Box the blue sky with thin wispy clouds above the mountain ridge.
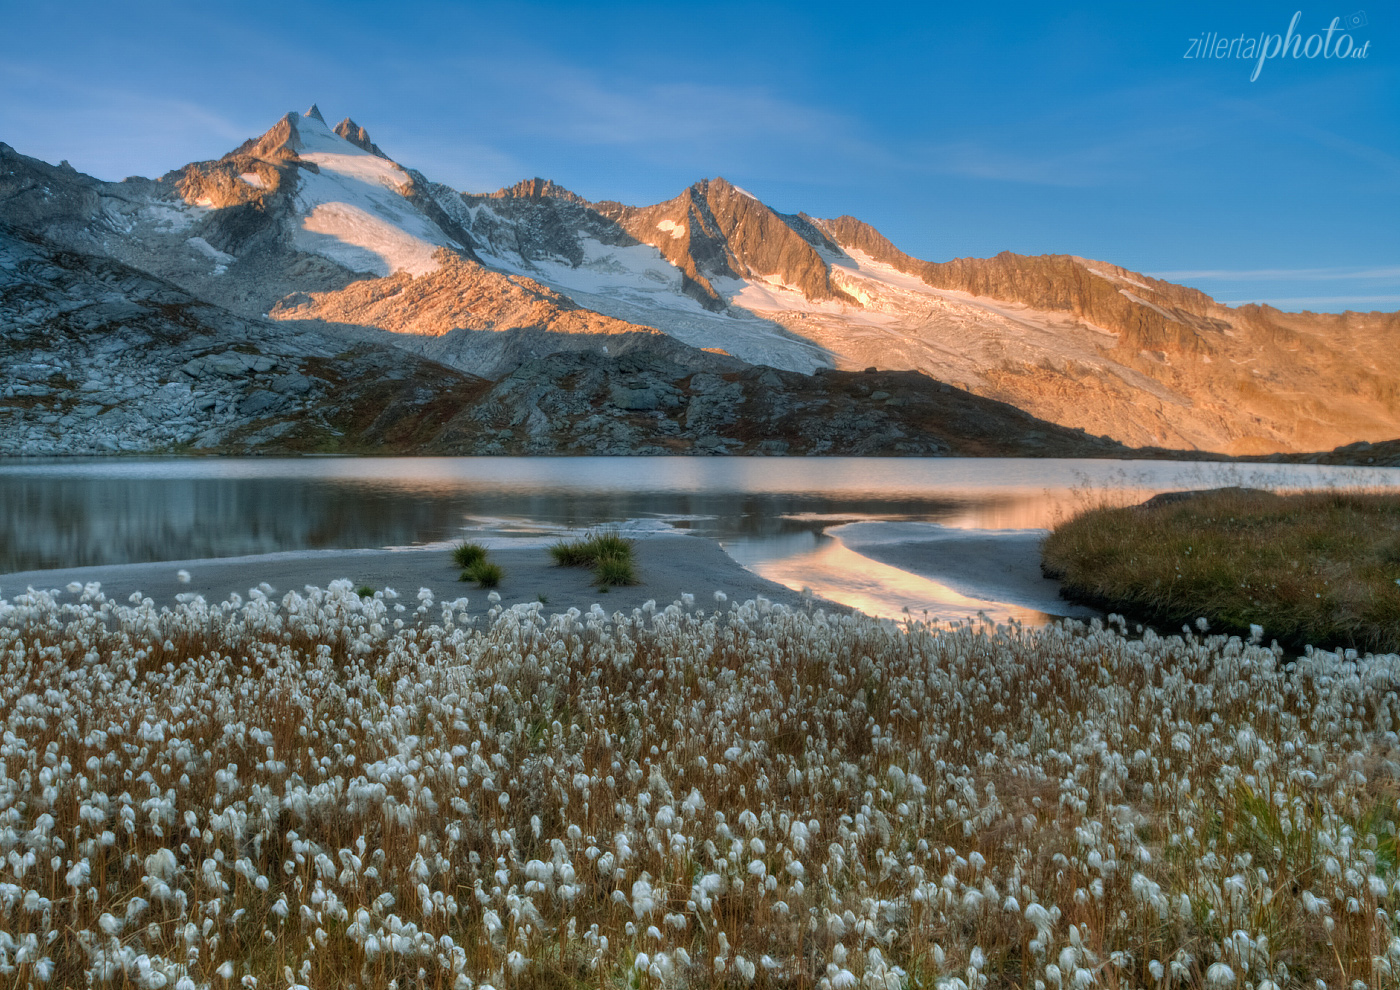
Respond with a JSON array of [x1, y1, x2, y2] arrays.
[[0, 0, 1400, 311]]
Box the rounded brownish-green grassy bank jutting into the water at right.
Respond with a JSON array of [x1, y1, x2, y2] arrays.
[[1043, 489, 1400, 653]]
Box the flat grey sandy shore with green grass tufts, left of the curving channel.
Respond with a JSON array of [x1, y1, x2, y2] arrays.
[[0, 536, 839, 613]]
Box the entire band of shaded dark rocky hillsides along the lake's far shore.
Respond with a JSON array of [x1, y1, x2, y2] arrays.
[[0, 224, 1123, 456]]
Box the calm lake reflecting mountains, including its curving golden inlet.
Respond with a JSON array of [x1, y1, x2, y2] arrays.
[[0, 458, 1400, 620]]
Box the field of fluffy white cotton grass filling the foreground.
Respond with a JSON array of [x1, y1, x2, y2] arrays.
[[0, 583, 1400, 990]]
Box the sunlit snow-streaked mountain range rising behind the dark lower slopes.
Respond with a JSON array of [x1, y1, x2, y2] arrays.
[[0, 106, 1400, 455]]
